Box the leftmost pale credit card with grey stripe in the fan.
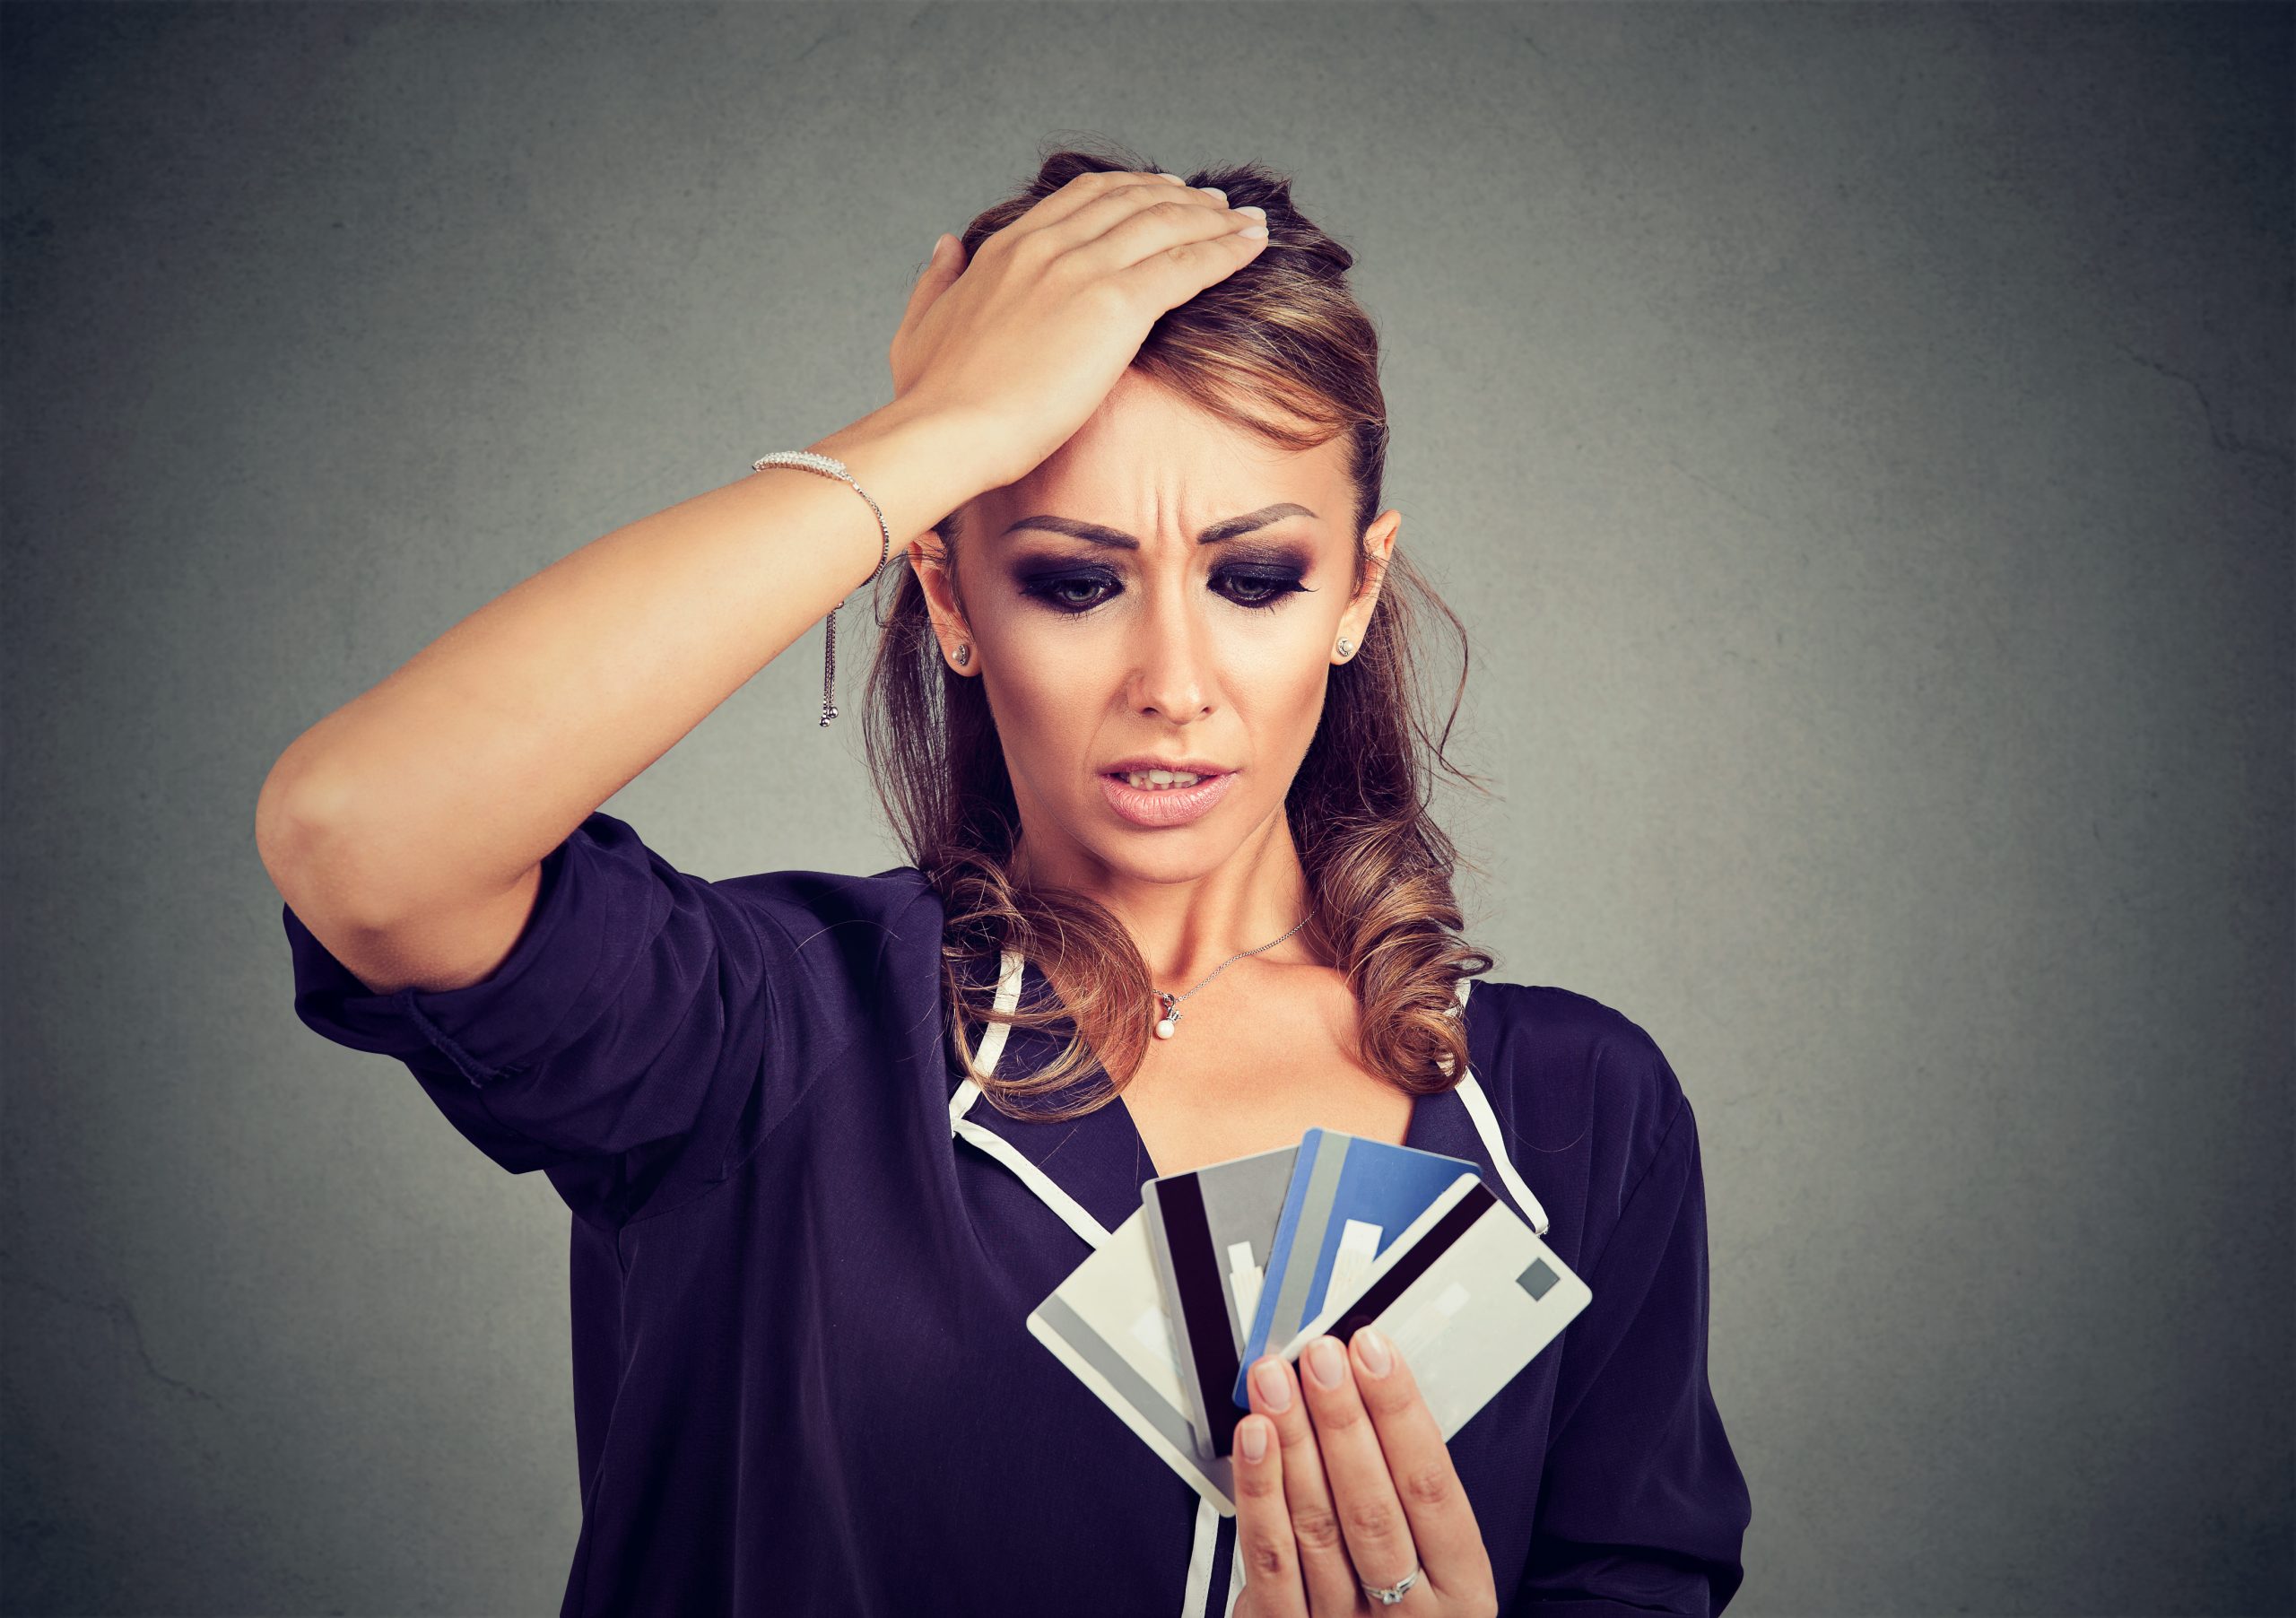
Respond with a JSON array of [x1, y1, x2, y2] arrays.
[[1022, 1203, 1235, 1517]]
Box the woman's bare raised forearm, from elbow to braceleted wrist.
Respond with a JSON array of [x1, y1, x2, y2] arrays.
[[257, 406, 983, 925]]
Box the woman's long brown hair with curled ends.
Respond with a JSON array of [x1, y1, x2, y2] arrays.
[[864, 143, 1495, 1120]]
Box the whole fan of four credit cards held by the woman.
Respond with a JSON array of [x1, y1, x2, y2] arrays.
[[1029, 1129, 1594, 1517]]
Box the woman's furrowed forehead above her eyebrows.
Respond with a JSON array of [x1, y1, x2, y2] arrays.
[[978, 372, 1354, 544]]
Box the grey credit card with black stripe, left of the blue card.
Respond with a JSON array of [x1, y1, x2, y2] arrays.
[[1141, 1145, 1300, 1459]]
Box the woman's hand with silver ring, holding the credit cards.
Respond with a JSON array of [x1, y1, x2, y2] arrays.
[[1233, 1327, 1500, 1618]]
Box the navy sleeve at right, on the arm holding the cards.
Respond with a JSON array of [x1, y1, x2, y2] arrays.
[[1506, 1092, 1752, 1618]]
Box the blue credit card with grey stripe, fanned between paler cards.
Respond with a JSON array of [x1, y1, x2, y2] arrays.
[[1229, 1129, 1481, 1409]]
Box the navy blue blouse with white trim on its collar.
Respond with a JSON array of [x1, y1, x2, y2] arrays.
[[283, 813, 1750, 1618]]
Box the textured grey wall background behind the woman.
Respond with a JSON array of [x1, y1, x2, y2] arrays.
[[0, 4, 2296, 1614]]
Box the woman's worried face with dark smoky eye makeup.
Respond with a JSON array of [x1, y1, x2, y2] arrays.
[[911, 372, 1403, 891]]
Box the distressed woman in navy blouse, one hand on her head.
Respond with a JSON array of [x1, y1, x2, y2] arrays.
[[257, 152, 1750, 1618]]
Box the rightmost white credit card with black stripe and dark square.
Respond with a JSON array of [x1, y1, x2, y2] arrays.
[[1281, 1175, 1594, 1441]]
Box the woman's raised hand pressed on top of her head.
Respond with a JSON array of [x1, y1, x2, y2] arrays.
[[891, 170, 1267, 489]]
